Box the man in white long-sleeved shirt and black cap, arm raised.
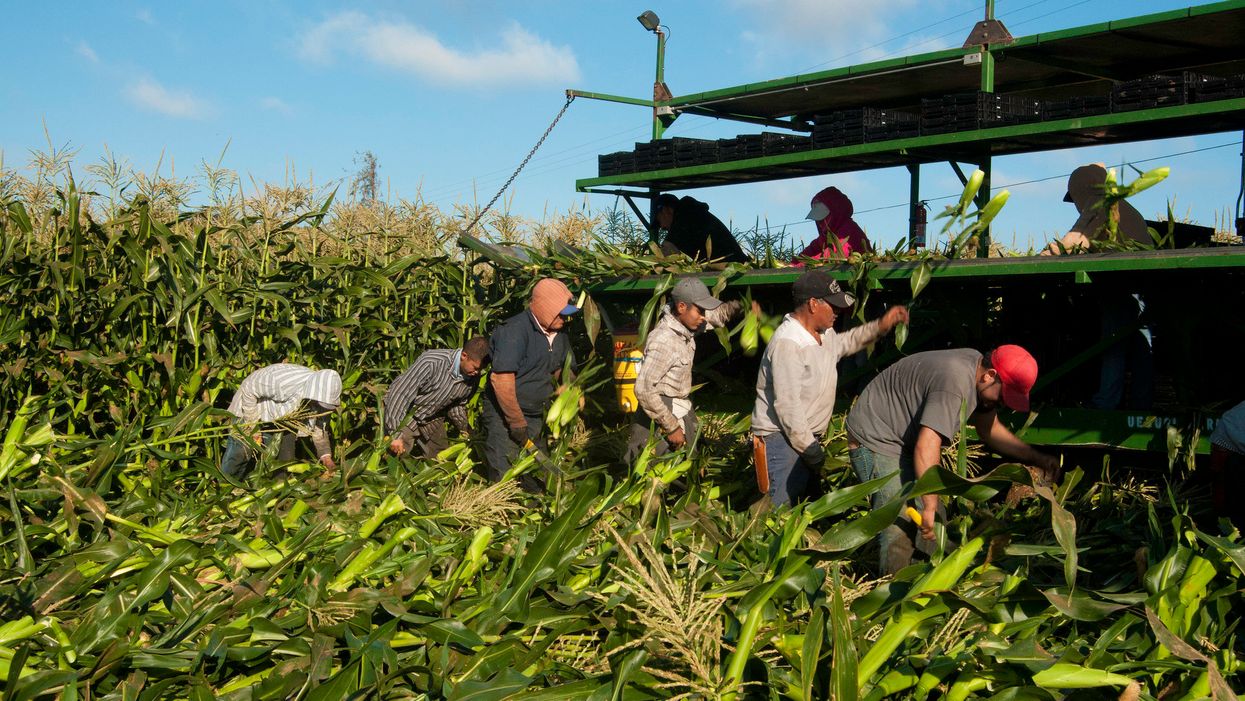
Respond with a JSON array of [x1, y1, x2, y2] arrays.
[[752, 270, 908, 506]]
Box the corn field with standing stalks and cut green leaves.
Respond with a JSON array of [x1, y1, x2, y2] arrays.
[[0, 164, 1245, 701]]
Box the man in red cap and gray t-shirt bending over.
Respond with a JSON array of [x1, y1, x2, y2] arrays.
[[847, 345, 1059, 574]]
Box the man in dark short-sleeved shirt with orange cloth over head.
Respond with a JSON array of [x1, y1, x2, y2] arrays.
[[482, 278, 579, 492]]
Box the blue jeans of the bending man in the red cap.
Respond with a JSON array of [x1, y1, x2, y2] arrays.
[[848, 446, 942, 574]]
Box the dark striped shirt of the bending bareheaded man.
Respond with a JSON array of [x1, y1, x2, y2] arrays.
[[383, 349, 478, 436]]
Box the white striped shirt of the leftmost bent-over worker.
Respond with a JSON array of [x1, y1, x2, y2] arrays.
[[229, 362, 341, 423]]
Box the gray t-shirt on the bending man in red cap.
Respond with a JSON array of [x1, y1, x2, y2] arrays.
[[847, 349, 981, 457]]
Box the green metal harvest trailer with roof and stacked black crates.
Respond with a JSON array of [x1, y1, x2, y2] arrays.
[[568, 0, 1245, 451]]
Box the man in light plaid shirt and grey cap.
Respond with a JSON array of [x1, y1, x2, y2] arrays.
[[626, 278, 761, 462]]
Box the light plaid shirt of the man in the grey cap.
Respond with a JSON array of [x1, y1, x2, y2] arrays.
[[635, 301, 743, 433]]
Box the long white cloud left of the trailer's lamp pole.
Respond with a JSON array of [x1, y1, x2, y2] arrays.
[[299, 11, 580, 87]]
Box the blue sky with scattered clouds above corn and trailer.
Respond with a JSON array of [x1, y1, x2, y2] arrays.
[[0, 0, 1241, 252]]
